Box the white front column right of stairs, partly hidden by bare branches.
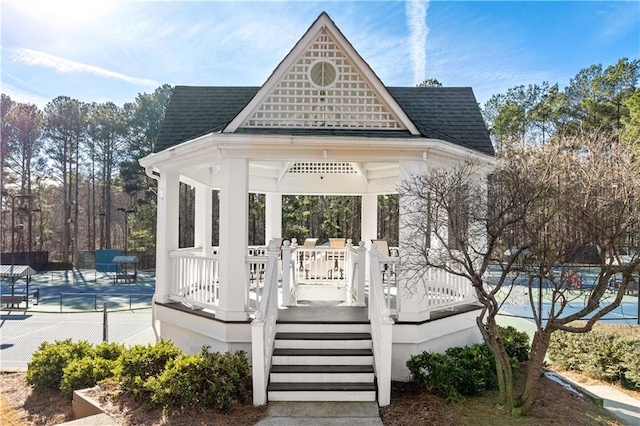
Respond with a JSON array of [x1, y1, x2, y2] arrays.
[[398, 161, 428, 321]]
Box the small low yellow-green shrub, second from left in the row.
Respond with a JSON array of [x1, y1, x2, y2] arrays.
[[60, 357, 116, 396]]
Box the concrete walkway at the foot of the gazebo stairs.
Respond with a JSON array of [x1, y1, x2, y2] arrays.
[[257, 402, 382, 426]]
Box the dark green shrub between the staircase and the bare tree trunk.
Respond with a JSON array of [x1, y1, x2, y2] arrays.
[[407, 344, 497, 402]]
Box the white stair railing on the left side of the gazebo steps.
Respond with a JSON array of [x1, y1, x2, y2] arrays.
[[251, 247, 278, 405]]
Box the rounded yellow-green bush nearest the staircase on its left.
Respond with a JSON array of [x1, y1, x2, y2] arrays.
[[145, 347, 251, 412]]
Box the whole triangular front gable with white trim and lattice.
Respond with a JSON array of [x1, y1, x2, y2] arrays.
[[223, 12, 420, 135]]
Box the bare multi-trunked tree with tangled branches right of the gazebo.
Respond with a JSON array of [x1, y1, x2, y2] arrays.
[[400, 131, 640, 415]]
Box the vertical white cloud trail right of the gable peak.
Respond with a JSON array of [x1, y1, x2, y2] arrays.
[[407, 0, 429, 84]]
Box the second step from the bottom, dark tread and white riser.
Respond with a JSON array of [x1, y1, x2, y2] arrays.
[[270, 365, 375, 383]]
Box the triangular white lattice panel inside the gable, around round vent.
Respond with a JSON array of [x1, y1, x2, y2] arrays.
[[241, 29, 404, 130]]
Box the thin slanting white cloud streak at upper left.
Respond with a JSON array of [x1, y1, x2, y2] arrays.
[[12, 48, 160, 87]]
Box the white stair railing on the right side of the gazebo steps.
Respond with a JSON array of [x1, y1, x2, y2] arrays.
[[369, 244, 394, 407]]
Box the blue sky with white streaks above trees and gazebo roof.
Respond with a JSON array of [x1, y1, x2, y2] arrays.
[[0, 0, 640, 107]]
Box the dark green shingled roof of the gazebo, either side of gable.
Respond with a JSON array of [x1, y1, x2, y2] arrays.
[[155, 86, 494, 155]]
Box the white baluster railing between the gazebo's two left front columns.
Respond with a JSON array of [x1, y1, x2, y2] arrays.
[[169, 248, 220, 309]]
